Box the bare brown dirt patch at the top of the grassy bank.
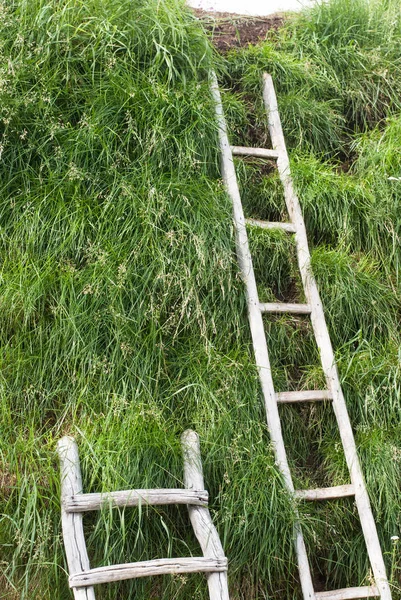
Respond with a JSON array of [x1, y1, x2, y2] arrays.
[[193, 9, 284, 53]]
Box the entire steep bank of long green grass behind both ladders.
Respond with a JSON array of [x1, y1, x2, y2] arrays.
[[0, 0, 401, 600]]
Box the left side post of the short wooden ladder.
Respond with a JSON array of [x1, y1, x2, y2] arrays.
[[57, 436, 95, 600]]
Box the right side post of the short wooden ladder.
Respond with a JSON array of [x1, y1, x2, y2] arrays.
[[181, 430, 229, 600]]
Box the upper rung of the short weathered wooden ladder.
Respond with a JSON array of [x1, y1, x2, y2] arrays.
[[64, 489, 209, 512]]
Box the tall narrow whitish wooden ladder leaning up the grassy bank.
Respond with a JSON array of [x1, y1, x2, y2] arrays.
[[212, 73, 391, 600]]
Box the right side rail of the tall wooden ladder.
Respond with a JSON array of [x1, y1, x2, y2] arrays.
[[263, 73, 391, 600]]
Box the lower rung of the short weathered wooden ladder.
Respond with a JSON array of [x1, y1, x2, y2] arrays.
[[68, 556, 227, 588]]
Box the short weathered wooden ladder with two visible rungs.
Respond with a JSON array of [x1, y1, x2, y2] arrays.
[[58, 430, 229, 600]]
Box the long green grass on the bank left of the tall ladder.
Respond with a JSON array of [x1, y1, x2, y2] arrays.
[[0, 0, 292, 599]]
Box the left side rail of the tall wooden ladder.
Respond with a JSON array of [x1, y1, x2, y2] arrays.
[[209, 73, 315, 600]]
